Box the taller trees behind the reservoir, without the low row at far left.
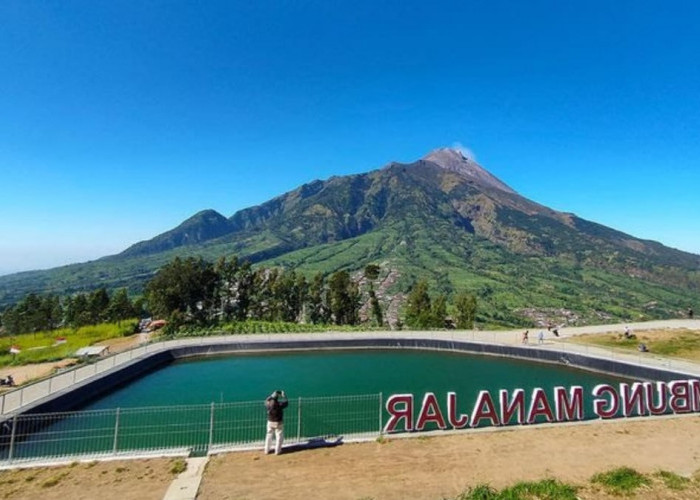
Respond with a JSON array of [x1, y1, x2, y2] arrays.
[[145, 256, 477, 330]]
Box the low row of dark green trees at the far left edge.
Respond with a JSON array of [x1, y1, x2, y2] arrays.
[[0, 288, 143, 335]]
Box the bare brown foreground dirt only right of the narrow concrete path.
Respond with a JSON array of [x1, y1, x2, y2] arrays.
[[197, 416, 700, 500]]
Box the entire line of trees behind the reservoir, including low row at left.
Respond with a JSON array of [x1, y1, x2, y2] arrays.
[[1, 256, 477, 335]]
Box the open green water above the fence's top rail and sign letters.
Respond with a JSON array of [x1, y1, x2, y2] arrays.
[[79, 350, 620, 409]]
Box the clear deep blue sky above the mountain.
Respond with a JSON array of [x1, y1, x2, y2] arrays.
[[0, 0, 700, 274]]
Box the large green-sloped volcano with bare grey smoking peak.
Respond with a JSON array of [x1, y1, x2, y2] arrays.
[[0, 148, 700, 325]]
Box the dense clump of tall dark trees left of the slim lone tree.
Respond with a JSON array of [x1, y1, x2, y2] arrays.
[[145, 256, 361, 329]]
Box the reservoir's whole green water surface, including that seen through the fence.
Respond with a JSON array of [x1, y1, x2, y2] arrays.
[[5, 348, 624, 460]]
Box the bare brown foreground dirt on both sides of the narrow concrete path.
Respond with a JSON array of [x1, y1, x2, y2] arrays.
[[0, 416, 700, 500]]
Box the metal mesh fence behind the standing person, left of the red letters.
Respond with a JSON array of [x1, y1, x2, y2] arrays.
[[0, 393, 383, 466]]
